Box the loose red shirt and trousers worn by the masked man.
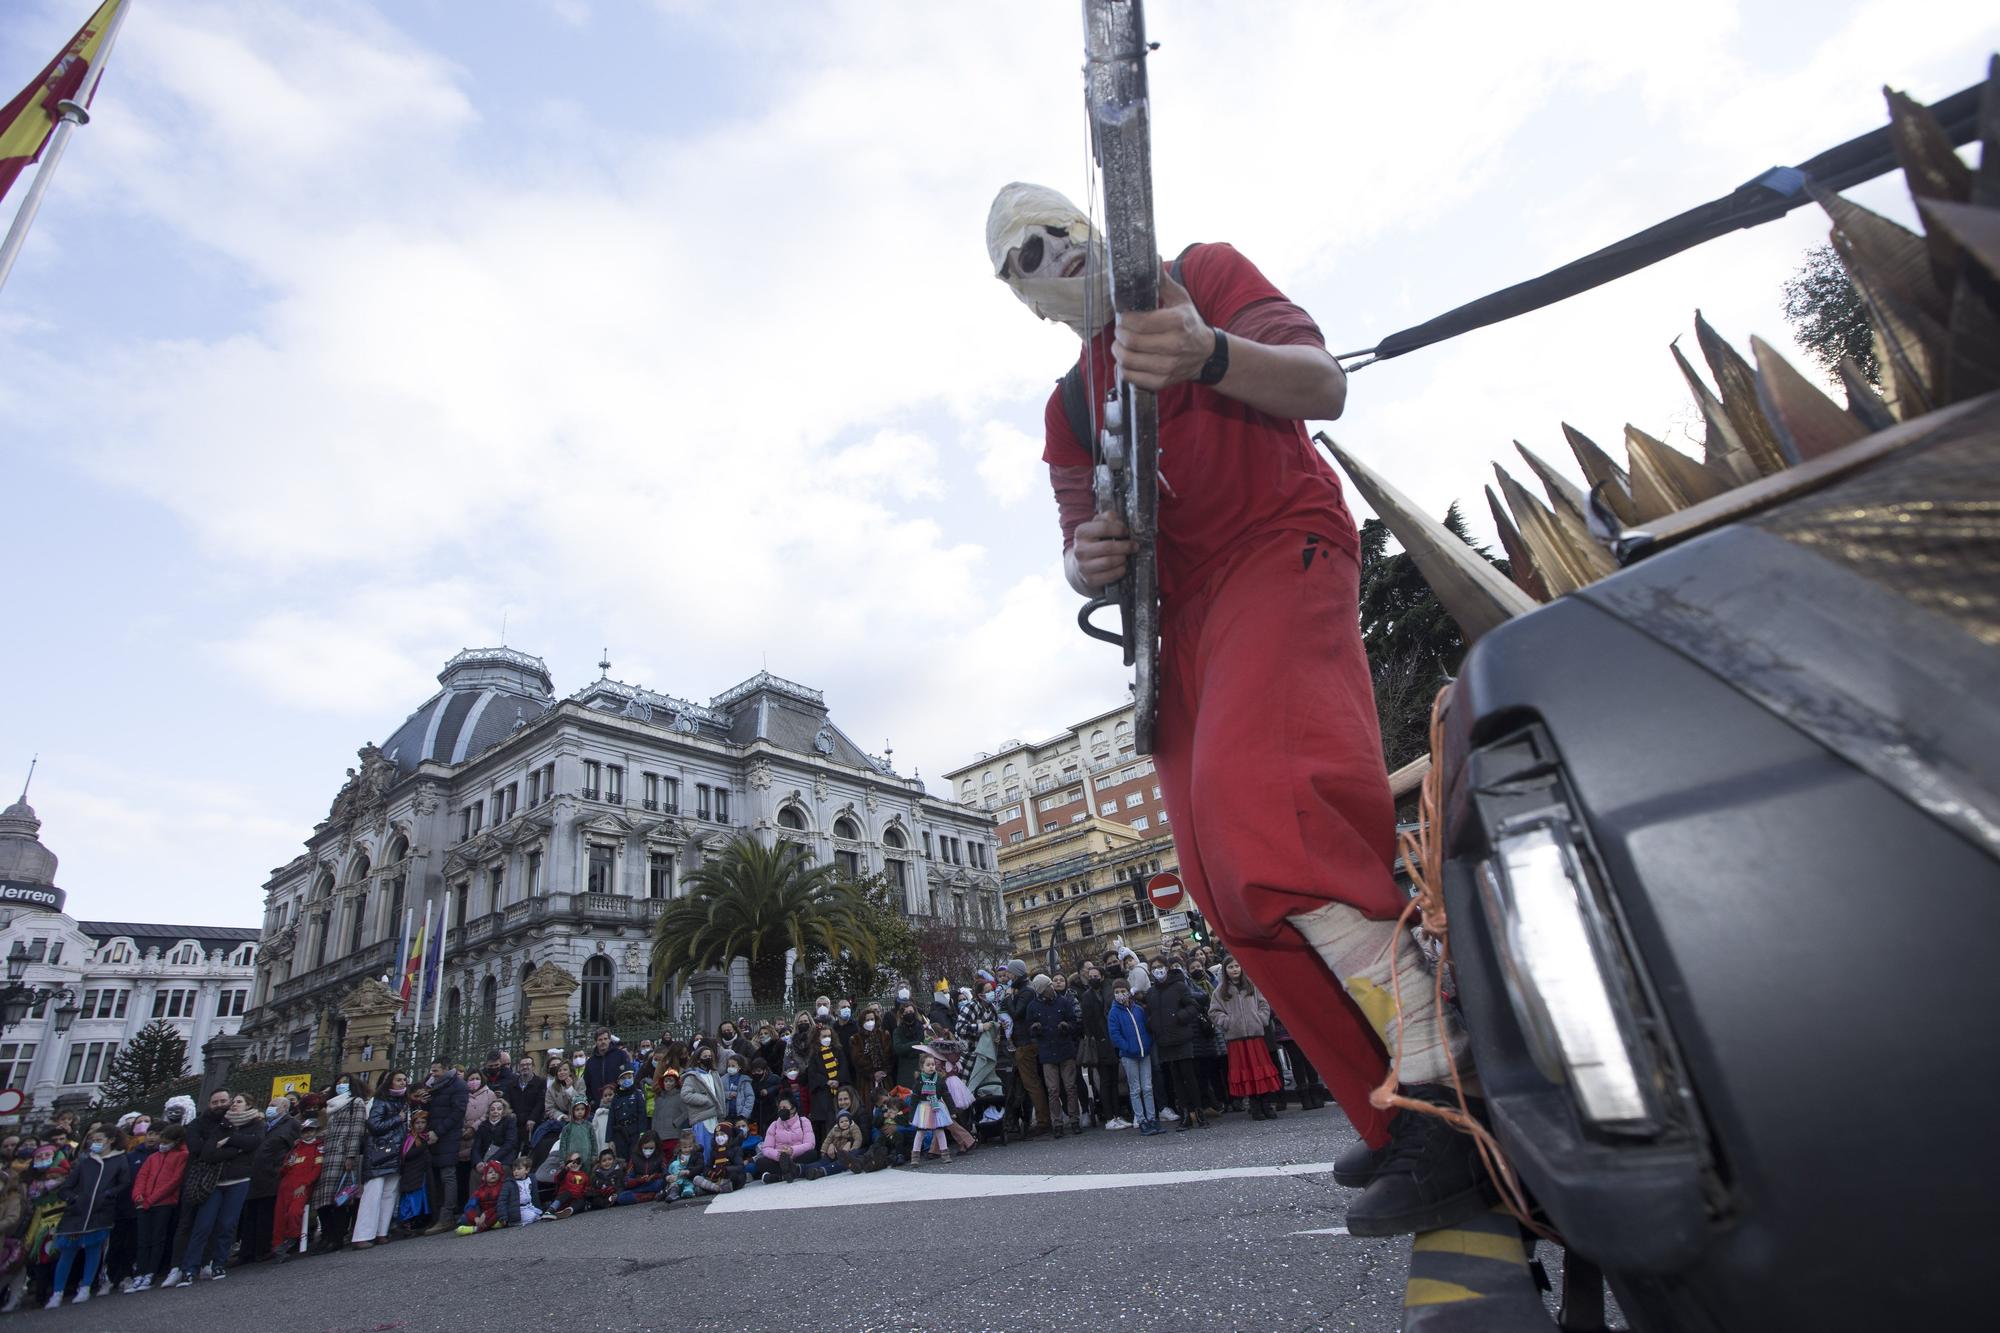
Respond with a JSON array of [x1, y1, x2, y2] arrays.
[[1042, 244, 1404, 1145]]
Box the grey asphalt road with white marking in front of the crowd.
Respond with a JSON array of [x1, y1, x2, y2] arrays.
[[19, 1107, 1472, 1333]]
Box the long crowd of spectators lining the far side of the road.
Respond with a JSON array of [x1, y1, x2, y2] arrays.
[[0, 945, 1326, 1309]]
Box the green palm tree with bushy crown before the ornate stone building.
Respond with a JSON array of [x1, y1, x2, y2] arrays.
[[652, 835, 876, 1005]]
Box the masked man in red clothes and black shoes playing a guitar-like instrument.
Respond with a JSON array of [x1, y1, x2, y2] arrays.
[[986, 182, 1486, 1235]]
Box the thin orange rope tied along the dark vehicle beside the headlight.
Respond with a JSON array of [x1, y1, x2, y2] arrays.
[[1368, 685, 1562, 1245]]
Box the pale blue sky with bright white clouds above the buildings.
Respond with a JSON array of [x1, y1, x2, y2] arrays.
[[0, 0, 2000, 923]]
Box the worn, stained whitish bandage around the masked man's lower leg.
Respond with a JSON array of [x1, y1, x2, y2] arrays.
[[1288, 903, 1472, 1083]]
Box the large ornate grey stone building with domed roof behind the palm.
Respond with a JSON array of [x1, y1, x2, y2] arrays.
[[244, 648, 1006, 1057]]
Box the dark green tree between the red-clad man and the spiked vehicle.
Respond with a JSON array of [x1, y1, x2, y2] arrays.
[[1360, 500, 1506, 771]]
